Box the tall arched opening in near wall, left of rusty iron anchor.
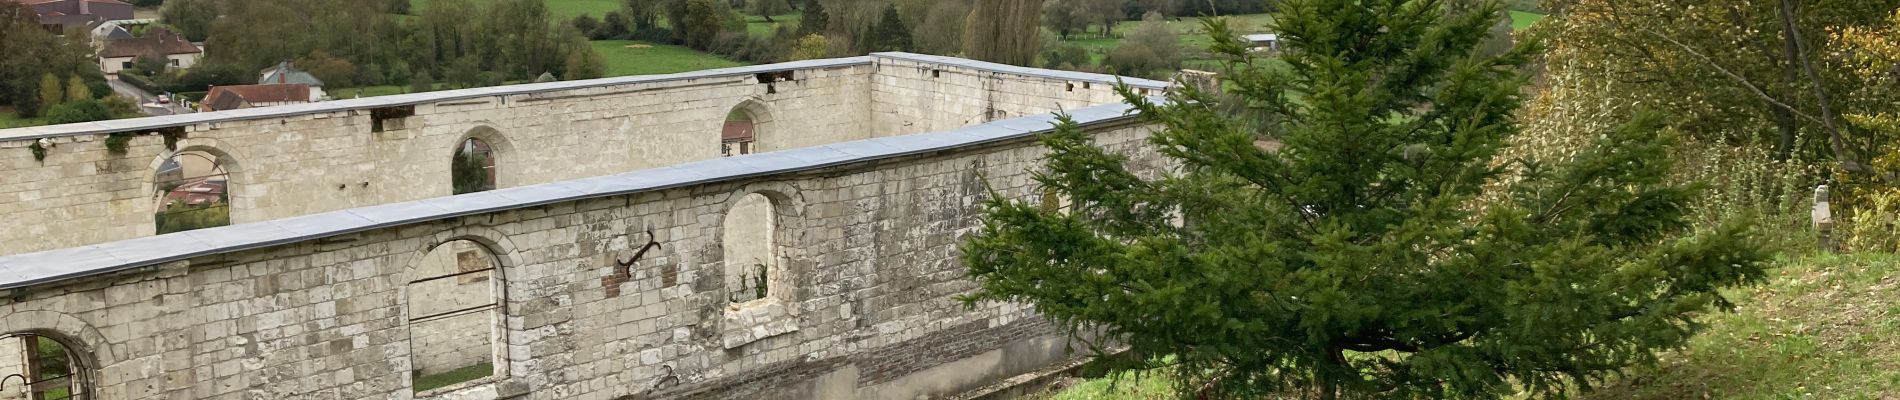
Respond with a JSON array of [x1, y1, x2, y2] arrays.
[[405, 241, 502, 392]]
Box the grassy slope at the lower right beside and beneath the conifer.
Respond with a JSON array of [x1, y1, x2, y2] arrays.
[[1037, 254, 1900, 400]]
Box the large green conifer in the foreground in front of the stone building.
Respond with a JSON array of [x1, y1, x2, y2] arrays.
[[963, 0, 1769, 398]]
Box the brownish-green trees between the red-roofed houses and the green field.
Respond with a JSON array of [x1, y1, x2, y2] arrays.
[[160, 0, 606, 91]]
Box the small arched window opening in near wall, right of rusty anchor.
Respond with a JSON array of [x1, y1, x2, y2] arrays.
[[720, 193, 779, 303]]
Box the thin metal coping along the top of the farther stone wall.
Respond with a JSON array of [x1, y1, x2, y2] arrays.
[[0, 53, 1169, 140]]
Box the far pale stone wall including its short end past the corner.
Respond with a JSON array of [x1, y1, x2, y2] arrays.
[[0, 53, 1153, 254]]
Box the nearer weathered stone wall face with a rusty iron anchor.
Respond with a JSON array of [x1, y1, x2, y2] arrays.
[[0, 118, 1155, 400]]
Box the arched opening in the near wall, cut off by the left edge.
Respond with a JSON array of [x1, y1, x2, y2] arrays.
[[0, 334, 93, 400]]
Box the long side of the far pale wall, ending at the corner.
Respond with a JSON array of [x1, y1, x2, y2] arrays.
[[0, 66, 870, 254]]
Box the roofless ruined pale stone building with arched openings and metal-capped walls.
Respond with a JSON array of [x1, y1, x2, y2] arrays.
[[0, 53, 1167, 400]]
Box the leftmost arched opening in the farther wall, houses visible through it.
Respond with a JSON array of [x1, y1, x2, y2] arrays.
[[152, 150, 232, 235]]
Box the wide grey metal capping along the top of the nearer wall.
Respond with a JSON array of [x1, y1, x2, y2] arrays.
[[0, 102, 1134, 290]]
